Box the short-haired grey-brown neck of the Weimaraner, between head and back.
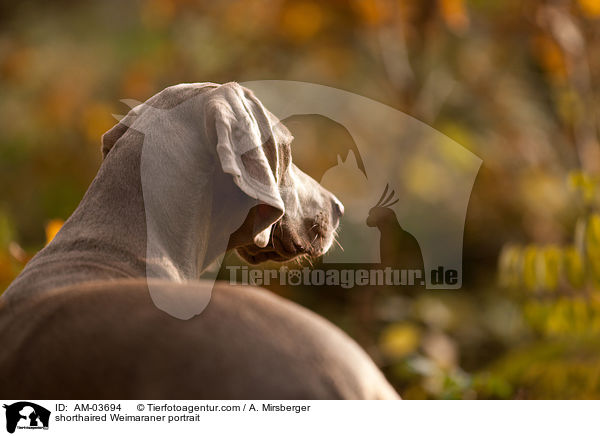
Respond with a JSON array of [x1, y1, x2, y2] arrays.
[[5, 130, 248, 297]]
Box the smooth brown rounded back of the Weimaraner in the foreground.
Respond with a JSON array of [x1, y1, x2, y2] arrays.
[[0, 280, 398, 399]]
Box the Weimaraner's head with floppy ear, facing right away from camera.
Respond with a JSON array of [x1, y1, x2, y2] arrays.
[[103, 83, 344, 263]]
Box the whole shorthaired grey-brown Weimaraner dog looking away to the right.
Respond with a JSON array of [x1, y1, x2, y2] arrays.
[[0, 83, 398, 399]]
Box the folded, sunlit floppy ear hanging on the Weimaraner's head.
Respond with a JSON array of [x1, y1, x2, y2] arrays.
[[204, 83, 285, 247]]
